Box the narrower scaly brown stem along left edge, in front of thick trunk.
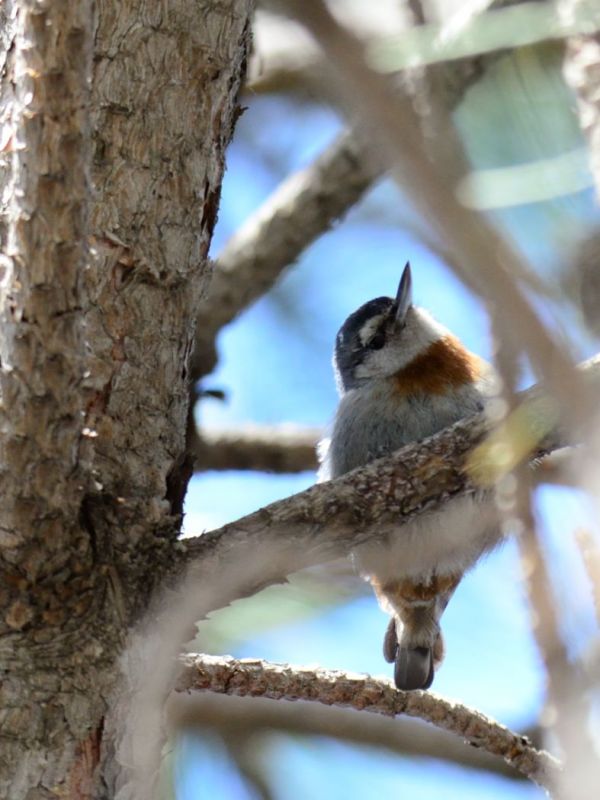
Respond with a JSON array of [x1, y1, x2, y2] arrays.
[[0, 0, 99, 798]]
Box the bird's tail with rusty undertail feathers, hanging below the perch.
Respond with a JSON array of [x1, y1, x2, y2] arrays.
[[375, 576, 460, 690]]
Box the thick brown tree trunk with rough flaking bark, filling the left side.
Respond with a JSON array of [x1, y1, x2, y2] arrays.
[[0, 0, 251, 800]]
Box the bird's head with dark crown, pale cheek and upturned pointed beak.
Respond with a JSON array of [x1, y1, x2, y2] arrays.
[[333, 263, 448, 394]]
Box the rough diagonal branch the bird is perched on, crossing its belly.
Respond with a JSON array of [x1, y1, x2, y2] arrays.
[[180, 357, 600, 608]]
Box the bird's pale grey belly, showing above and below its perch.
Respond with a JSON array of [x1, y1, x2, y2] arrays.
[[328, 388, 498, 580]]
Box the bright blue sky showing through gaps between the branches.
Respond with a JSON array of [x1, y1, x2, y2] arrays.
[[175, 72, 595, 800]]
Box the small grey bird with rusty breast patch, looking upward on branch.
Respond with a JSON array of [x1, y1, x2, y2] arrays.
[[319, 263, 499, 689]]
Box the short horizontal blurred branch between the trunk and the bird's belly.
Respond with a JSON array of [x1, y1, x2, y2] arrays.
[[189, 425, 321, 473]]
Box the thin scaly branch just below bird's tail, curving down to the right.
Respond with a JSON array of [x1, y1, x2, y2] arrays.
[[175, 654, 560, 788]]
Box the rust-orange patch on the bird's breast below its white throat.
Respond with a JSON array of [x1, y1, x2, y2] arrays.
[[394, 336, 483, 395]]
